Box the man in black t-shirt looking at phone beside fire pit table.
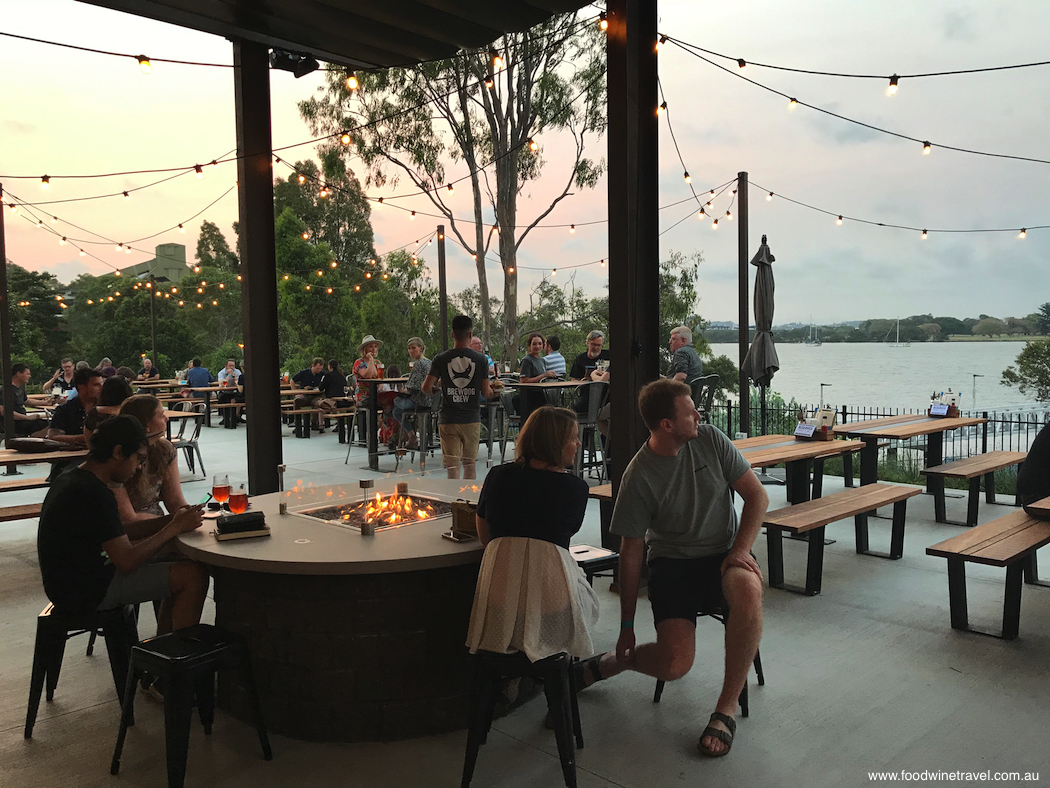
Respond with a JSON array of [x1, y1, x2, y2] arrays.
[[37, 416, 208, 635]]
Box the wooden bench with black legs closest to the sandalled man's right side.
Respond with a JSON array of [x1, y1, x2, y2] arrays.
[[763, 484, 922, 597]]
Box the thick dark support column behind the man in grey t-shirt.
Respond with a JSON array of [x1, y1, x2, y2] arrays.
[[607, 0, 662, 488]]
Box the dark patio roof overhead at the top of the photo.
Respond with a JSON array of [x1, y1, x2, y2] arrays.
[[75, 0, 587, 68]]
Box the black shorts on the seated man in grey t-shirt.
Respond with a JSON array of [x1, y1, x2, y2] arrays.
[[649, 551, 729, 625]]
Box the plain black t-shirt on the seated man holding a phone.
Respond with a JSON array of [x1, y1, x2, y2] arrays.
[[37, 468, 124, 613]]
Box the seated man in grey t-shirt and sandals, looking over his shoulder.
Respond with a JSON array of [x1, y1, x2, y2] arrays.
[[581, 379, 769, 758]]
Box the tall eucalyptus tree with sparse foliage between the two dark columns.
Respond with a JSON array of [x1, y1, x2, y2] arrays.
[[299, 14, 606, 356]]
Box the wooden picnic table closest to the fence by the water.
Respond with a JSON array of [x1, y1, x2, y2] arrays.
[[832, 413, 988, 493]]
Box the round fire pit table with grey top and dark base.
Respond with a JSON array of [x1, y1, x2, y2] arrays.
[[179, 478, 483, 742]]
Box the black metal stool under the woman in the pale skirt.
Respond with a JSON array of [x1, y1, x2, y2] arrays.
[[461, 651, 584, 788]]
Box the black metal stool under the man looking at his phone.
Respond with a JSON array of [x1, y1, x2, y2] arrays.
[[25, 604, 139, 739]]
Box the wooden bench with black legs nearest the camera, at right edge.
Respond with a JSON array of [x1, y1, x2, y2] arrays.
[[926, 512, 1050, 640]]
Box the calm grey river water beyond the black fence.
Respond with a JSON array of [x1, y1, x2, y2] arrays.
[[711, 341, 1034, 411]]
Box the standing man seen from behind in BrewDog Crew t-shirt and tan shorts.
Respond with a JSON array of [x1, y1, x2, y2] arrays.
[[423, 314, 492, 479]]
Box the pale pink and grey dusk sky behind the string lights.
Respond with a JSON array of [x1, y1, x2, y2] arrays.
[[0, 0, 1050, 324]]
